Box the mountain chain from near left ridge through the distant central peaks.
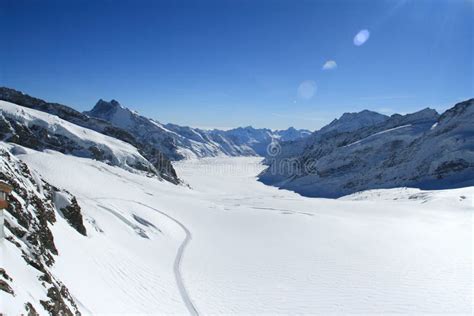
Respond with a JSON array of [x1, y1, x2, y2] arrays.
[[0, 87, 311, 184]]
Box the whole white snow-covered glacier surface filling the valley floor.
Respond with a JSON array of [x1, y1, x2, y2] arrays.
[[0, 150, 474, 314]]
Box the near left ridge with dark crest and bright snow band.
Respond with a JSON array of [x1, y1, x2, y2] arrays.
[[0, 87, 179, 184]]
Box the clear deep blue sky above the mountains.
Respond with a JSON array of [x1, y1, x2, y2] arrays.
[[0, 0, 474, 129]]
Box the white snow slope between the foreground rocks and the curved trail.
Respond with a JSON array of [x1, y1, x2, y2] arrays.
[[0, 145, 191, 314]]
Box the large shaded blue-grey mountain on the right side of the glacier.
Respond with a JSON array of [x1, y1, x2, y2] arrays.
[[260, 99, 474, 198]]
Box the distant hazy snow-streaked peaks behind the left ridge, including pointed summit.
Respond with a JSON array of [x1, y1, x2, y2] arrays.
[[84, 99, 310, 160]]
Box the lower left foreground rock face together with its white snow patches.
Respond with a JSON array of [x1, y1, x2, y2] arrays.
[[0, 145, 87, 315]]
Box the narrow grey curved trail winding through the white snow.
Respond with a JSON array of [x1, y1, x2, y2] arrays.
[[90, 198, 199, 316]]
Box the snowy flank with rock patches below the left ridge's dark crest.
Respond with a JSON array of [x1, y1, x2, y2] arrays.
[[0, 101, 164, 177]]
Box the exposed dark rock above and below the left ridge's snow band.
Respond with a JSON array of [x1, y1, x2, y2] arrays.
[[0, 87, 180, 184]]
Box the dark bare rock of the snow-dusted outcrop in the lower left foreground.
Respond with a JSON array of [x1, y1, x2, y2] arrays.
[[0, 148, 85, 315]]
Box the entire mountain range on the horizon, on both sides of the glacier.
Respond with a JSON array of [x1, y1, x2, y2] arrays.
[[0, 88, 474, 198]]
